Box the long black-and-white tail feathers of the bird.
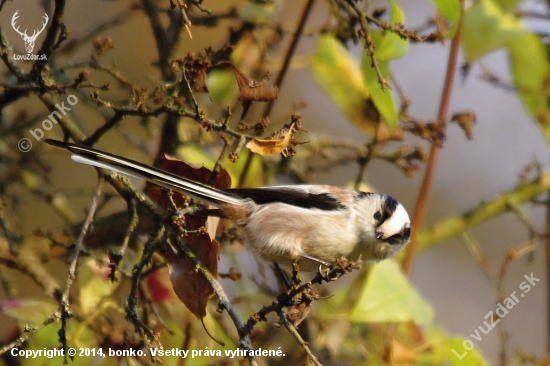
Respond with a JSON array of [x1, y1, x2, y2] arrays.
[[45, 139, 242, 206]]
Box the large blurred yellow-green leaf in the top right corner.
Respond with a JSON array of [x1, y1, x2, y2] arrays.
[[462, 0, 550, 142]]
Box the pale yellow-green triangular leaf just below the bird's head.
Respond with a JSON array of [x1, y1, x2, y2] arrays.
[[350, 260, 433, 326]]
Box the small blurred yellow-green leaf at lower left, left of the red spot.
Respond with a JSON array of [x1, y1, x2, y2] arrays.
[[77, 258, 117, 314]]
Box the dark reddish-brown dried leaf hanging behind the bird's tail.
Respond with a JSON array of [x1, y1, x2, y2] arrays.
[[146, 156, 231, 318]]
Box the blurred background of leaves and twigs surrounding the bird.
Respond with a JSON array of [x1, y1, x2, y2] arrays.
[[0, 0, 550, 365]]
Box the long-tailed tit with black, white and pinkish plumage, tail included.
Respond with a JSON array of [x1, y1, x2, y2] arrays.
[[46, 139, 411, 270]]
